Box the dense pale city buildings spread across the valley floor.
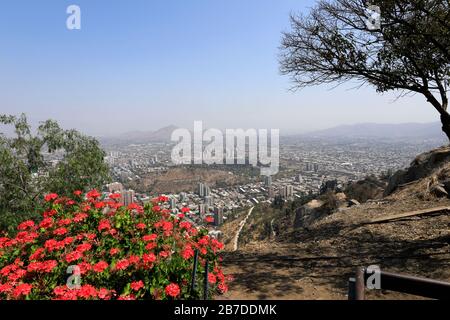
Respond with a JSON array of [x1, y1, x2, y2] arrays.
[[94, 138, 442, 230]]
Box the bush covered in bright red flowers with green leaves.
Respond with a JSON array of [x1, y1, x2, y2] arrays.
[[0, 190, 227, 300]]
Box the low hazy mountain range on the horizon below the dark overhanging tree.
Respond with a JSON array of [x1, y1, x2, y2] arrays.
[[301, 122, 445, 139]]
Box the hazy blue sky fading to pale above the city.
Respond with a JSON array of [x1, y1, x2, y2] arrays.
[[0, 0, 438, 135]]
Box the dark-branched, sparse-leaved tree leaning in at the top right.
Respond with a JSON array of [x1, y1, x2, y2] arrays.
[[280, 0, 450, 139]]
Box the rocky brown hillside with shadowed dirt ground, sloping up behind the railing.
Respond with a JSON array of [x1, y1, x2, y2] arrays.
[[225, 147, 450, 299]]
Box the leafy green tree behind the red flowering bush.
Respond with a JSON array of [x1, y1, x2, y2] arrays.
[[0, 114, 109, 230]]
